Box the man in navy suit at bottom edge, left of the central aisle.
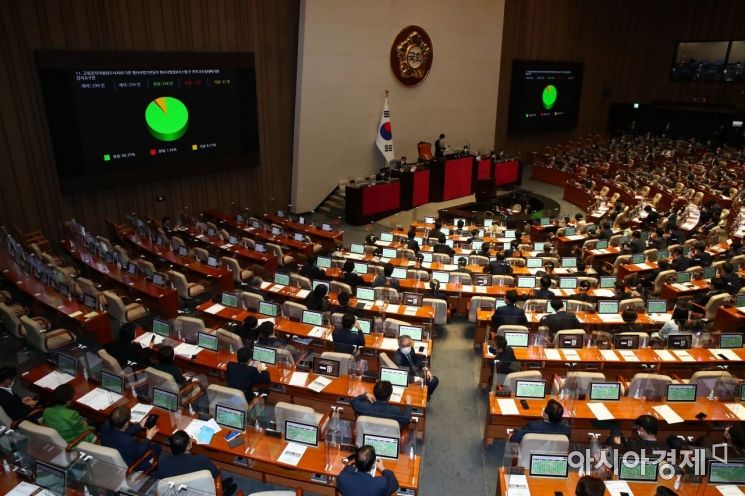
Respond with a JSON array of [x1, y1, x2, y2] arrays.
[[336, 445, 398, 496]]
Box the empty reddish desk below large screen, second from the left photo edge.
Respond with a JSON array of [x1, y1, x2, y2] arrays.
[[62, 240, 180, 318]]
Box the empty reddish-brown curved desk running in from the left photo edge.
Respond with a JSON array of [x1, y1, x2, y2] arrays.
[[0, 247, 114, 344]]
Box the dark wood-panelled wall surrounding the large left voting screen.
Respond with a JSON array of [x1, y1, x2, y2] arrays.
[[0, 0, 299, 239]]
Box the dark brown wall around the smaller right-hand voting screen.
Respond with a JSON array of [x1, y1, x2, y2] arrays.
[[494, 0, 745, 153]]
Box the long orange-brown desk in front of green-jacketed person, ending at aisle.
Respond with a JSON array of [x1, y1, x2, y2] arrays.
[[21, 362, 421, 496]]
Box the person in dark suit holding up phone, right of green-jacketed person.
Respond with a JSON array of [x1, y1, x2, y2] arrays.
[[101, 406, 160, 470]]
